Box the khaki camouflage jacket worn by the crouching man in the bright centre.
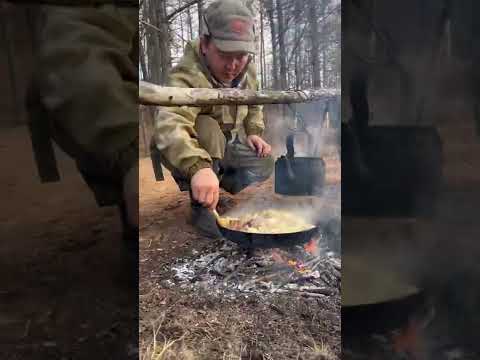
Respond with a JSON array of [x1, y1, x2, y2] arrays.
[[155, 40, 265, 178]]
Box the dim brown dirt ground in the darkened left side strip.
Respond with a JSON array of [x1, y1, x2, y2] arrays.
[[0, 128, 138, 360]]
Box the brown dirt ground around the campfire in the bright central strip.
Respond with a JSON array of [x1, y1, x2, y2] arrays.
[[140, 153, 340, 360]]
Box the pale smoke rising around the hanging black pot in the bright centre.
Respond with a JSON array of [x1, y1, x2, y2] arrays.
[[227, 103, 341, 251]]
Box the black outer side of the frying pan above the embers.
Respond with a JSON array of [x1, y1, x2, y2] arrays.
[[216, 210, 317, 249]]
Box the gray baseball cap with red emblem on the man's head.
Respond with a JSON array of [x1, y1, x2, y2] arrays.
[[203, 0, 255, 54]]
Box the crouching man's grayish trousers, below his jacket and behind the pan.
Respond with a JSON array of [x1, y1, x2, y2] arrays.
[[172, 115, 274, 194]]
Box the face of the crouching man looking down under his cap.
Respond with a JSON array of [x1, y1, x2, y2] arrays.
[[201, 39, 248, 83]]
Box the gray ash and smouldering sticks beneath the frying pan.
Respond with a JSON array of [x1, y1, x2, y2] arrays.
[[169, 238, 341, 299]]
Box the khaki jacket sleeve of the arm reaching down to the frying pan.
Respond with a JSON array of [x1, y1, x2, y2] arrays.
[[155, 66, 212, 179]]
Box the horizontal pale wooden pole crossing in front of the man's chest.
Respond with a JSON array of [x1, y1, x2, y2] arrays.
[[139, 81, 340, 106]]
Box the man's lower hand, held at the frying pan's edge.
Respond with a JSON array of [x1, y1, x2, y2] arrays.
[[190, 168, 220, 210]]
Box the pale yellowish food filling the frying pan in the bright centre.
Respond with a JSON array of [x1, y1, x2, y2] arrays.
[[219, 209, 315, 234]]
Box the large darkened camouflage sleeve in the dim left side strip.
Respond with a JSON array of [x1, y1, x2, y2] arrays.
[[36, 5, 138, 177]]
